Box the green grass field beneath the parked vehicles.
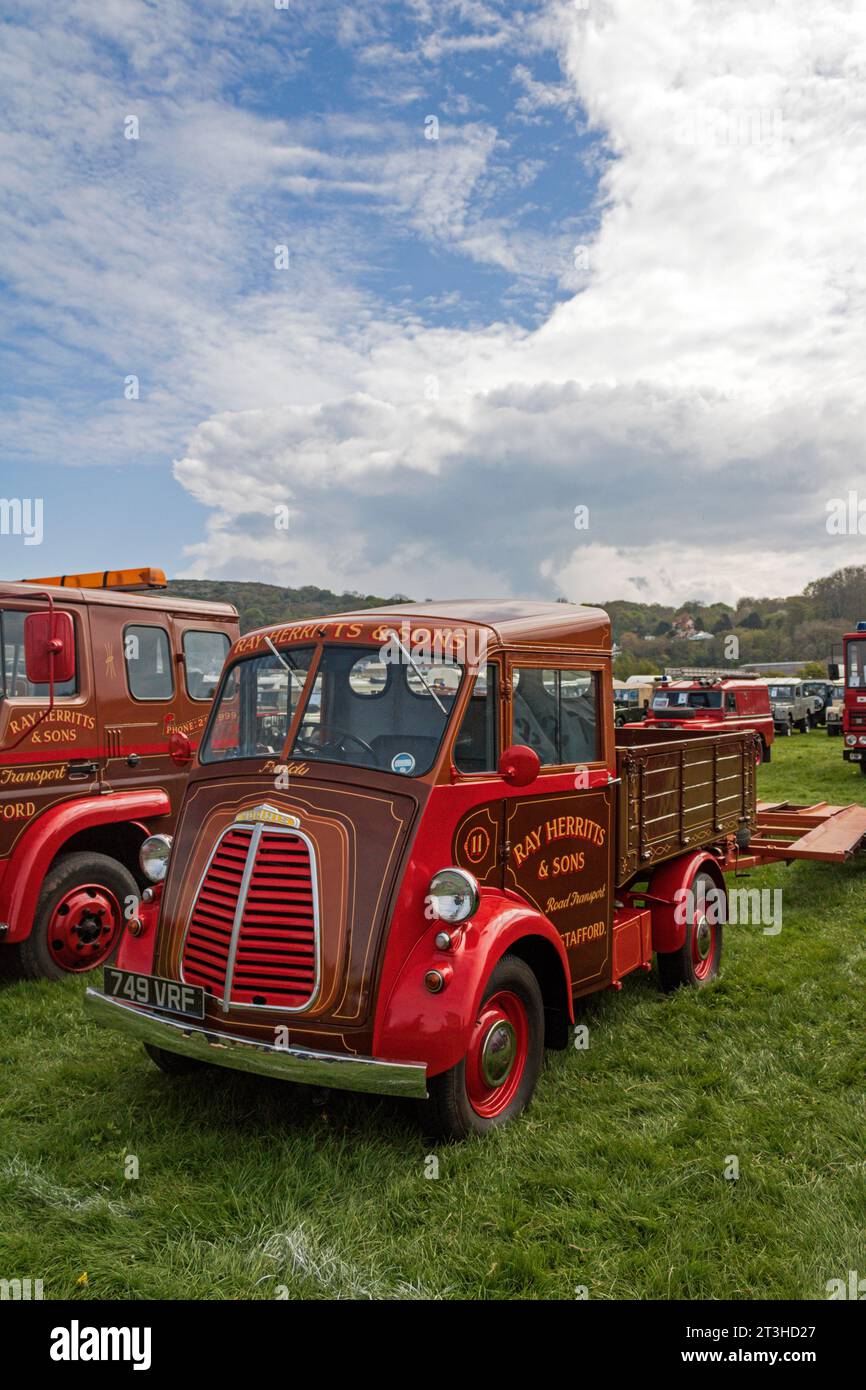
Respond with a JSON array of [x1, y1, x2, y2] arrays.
[[0, 730, 866, 1300]]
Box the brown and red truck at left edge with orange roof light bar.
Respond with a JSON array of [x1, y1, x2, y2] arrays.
[[0, 569, 238, 977]]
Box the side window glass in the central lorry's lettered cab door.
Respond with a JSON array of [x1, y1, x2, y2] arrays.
[[513, 666, 601, 767]]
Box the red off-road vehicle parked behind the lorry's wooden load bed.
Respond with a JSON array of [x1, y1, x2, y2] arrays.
[[645, 667, 772, 763]]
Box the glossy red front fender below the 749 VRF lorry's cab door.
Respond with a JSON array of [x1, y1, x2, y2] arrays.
[[373, 891, 574, 1076]]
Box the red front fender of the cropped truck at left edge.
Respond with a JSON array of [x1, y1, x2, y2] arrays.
[[0, 788, 171, 941]]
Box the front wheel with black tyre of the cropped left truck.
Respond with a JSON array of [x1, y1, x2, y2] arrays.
[[13, 853, 140, 980]]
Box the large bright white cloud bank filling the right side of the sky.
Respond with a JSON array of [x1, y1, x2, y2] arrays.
[[170, 0, 866, 599]]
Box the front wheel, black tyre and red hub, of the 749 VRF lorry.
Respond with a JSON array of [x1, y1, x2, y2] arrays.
[[421, 955, 545, 1140]]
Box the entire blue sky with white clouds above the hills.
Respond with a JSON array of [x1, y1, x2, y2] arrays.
[[0, 0, 866, 602]]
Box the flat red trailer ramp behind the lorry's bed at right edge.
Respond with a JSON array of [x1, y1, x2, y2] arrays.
[[738, 801, 866, 867]]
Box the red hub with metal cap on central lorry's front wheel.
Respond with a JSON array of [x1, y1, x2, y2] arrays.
[[466, 990, 530, 1119]]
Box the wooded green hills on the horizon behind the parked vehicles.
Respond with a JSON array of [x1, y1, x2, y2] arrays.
[[168, 566, 866, 678]]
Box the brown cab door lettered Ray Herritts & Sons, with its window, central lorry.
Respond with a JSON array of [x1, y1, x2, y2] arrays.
[[505, 657, 614, 995]]
